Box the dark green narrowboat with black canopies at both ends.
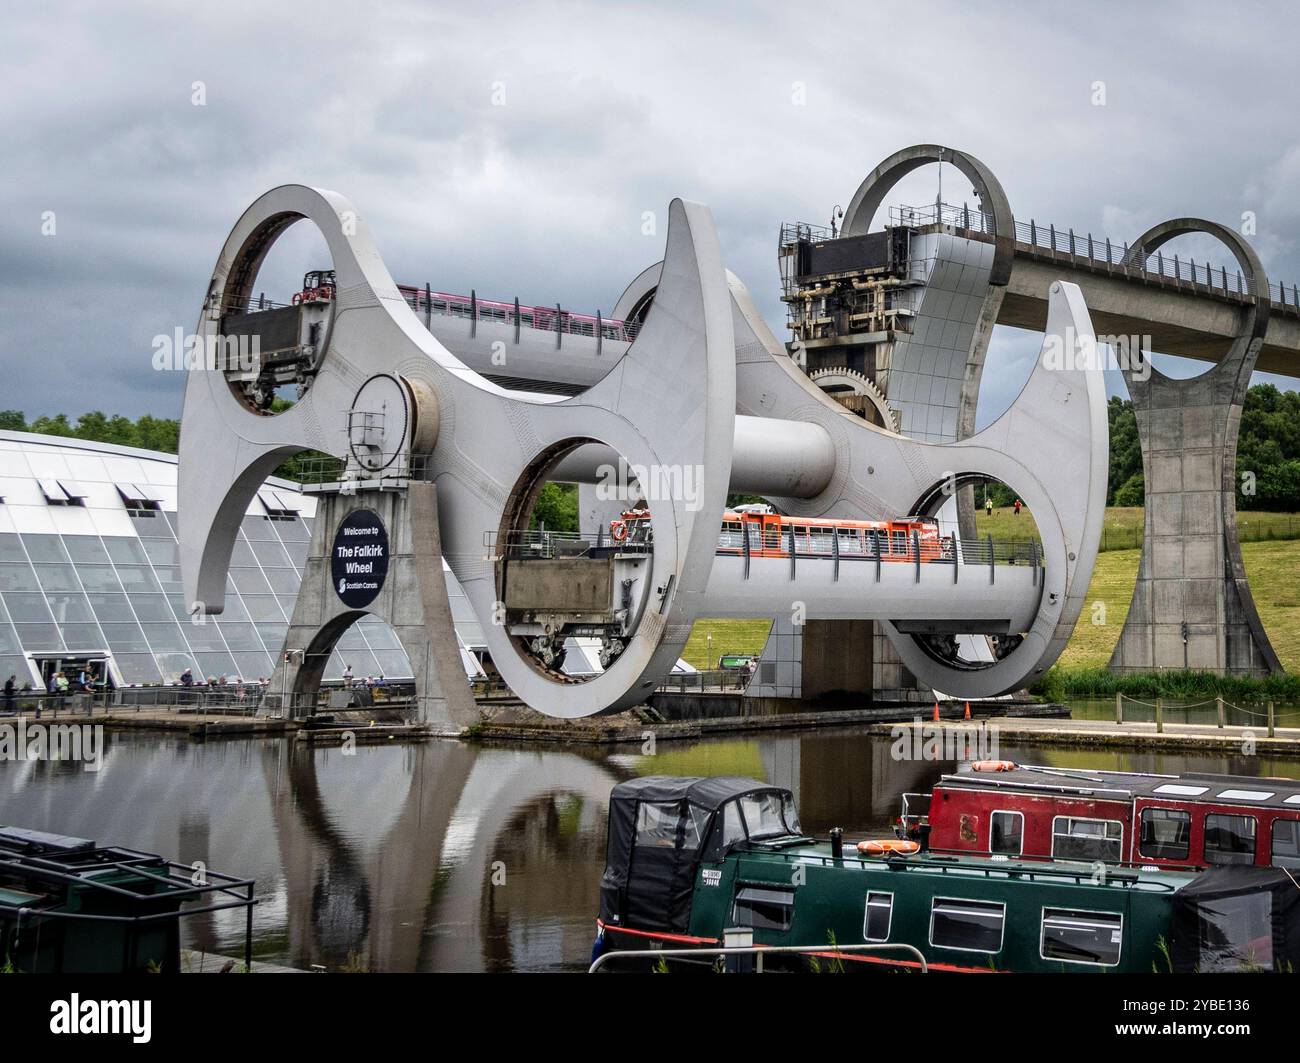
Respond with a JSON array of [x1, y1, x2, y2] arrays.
[[595, 777, 1300, 973]]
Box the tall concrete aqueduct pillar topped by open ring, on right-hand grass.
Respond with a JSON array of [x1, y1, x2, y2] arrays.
[[1110, 218, 1282, 676]]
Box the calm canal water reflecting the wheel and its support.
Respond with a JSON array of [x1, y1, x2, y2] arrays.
[[0, 712, 1300, 971]]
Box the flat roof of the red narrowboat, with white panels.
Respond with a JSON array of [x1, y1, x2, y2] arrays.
[[936, 764, 1300, 812]]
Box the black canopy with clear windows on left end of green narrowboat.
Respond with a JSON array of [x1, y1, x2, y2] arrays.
[[601, 776, 800, 932]]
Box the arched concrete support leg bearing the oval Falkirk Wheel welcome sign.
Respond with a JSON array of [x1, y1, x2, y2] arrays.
[[270, 482, 478, 729]]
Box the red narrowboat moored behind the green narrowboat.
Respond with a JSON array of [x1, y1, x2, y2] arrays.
[[898, 760, 1300, 868]]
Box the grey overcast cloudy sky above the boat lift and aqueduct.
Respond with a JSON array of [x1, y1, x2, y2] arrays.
[[0, 0, 1300, 422]]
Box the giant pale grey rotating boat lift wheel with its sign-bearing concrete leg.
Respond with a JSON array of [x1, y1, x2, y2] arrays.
[[179, 170, 1108, 726]]
